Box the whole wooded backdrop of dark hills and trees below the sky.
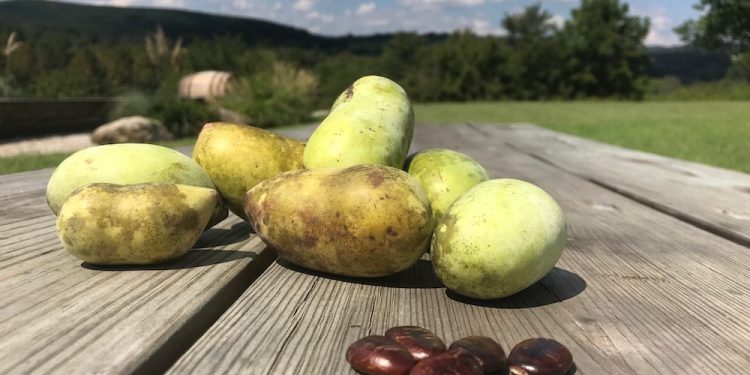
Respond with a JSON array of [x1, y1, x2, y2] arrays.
[[0, 0, 729, 103]]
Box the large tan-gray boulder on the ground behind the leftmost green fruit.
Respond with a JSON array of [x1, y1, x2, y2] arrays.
[[91, 116, 174, 145]]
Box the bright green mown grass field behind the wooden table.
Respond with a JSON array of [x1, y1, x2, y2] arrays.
[[0, 101, 750, 174]]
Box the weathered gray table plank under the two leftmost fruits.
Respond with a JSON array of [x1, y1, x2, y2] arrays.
[[0, 184, 274, 374]]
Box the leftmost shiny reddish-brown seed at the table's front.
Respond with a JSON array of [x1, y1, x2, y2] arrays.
[[346, 336, 415, 375]]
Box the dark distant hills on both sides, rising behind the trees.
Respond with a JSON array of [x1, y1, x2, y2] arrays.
[[0, 0, 730, 83]]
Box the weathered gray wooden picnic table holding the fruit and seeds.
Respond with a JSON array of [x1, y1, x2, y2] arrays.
[[0, 124, 750, 374]]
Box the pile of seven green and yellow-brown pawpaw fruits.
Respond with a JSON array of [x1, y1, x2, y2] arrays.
[[47, 76, 565, 299]]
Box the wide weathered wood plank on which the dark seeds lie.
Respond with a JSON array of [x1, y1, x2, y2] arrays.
[[170, 126, 750, 374]]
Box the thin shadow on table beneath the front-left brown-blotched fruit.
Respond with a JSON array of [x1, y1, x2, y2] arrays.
[[81, 249, 260, 271]]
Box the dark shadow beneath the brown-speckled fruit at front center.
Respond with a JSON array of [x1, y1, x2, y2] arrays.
[[276, 259, 443, 289]]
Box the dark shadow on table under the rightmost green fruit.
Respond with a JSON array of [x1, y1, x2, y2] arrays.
[[445, 267, 586, 309]]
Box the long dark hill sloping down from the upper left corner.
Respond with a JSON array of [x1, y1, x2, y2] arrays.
[[0, 0, 400, 54]]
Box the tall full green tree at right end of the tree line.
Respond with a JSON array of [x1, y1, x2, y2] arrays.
[[561, 0, 649, 98]]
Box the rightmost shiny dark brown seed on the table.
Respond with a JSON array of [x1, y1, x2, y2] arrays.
[[508, 338, 573, 375]]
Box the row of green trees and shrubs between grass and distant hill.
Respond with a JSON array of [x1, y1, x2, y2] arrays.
[[0, 0, 649, 102]]
